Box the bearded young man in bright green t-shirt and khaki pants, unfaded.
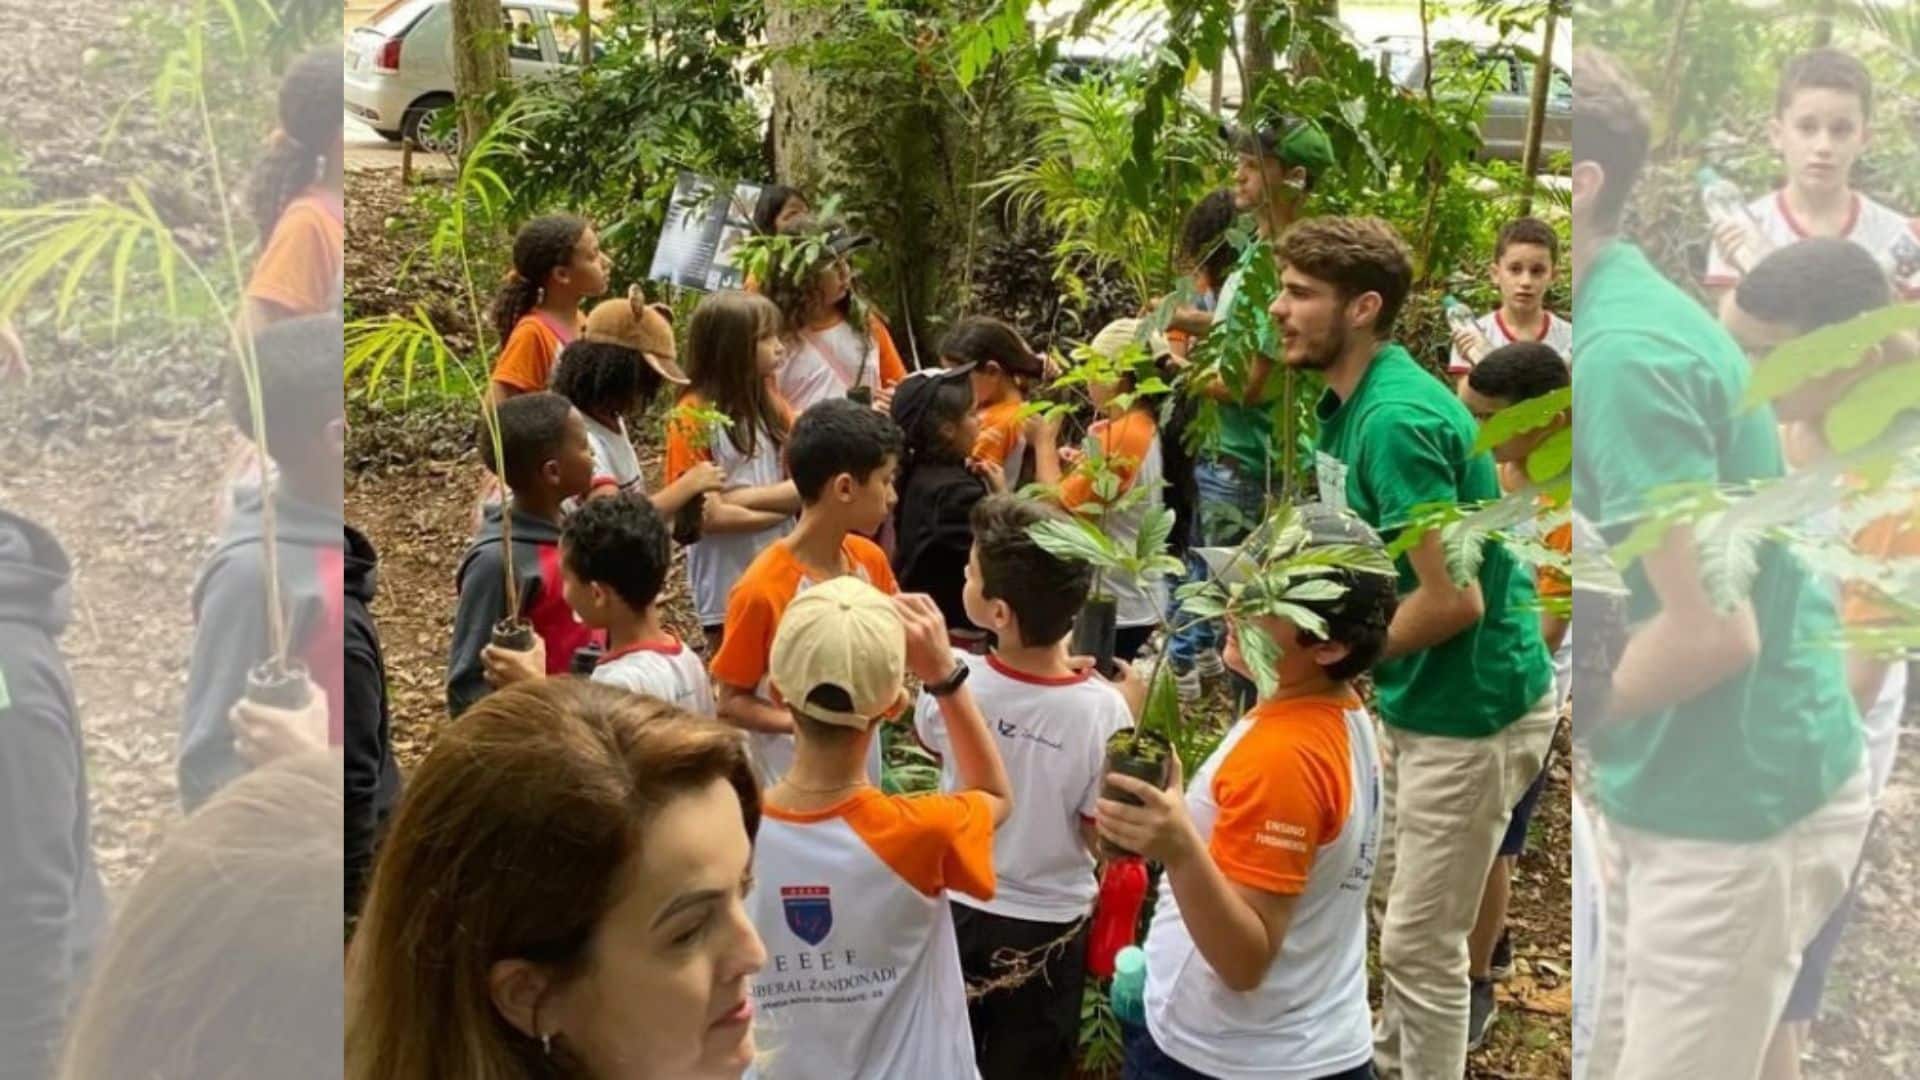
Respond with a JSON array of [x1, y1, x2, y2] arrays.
[[1273, 217, 1557, 1080]]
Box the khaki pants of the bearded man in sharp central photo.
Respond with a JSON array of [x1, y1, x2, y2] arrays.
[[1373, 692, 1559, 1080]]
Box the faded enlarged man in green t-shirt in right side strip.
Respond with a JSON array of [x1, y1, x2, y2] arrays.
[[1572, 50, 1870, 1080]]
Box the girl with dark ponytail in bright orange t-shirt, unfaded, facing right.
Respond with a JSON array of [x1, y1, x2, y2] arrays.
[[492, 213, 611, 402]]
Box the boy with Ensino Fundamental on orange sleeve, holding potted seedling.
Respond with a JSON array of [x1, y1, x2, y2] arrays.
[[1096, 505, 1396, 1080]]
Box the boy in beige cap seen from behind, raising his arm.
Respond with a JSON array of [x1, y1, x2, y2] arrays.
[[747, 575, 1012, 1080]]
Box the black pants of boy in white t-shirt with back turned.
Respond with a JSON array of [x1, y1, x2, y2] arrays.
[[952, 903, 1091, 1080]]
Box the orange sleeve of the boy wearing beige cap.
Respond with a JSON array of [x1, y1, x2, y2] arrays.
[[847, 792, 995, 899]]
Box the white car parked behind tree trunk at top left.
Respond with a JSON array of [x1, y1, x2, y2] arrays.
[[346, 0, 599, 150]]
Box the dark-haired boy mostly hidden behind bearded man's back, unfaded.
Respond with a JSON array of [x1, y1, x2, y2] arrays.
[[1459, 342, 1572, 1049]]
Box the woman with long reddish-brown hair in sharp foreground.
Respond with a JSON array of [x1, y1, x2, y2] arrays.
[[346, 678, 766, 1080]]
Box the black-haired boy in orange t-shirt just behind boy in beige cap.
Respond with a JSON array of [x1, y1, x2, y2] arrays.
[[710, 398, 900, 784]]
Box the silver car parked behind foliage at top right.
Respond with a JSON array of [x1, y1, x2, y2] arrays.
[[1373, 38, 1572, 161]]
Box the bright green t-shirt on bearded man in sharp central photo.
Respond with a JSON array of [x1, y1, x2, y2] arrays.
[[1313, 344, 1553, 738]]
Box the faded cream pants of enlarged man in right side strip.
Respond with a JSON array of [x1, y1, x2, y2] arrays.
[[1586, 767, 1872, 1080]]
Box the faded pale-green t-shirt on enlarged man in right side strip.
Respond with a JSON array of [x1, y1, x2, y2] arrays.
[[1572, 240, 1862, 842]]
